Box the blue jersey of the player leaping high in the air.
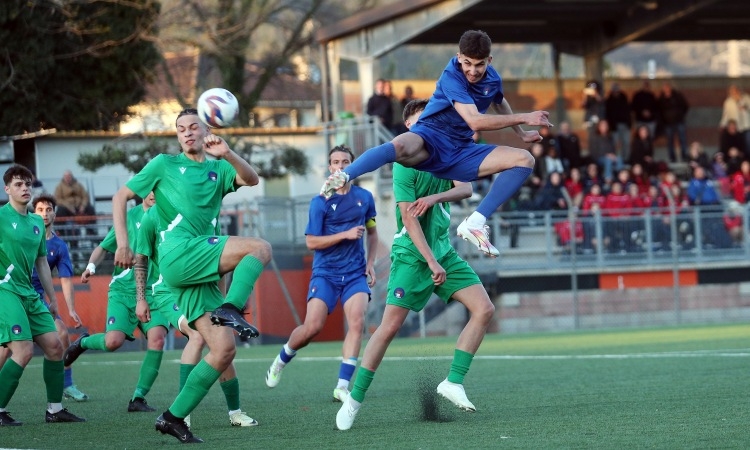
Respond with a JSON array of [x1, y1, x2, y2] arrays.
[[417, 56, 503, 142]]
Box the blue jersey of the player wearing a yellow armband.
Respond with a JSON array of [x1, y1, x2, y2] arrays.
[[305, 185, 375, 277]]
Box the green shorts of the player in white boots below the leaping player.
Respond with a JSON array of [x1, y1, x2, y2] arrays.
[[386, 250, 482, 311]]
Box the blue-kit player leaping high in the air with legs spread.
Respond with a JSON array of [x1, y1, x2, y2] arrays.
[[320, 30, 552, 257]]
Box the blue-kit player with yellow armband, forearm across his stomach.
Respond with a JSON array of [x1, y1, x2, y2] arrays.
[[266, 145, 378, 402]]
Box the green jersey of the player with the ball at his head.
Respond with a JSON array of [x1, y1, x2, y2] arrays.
[[127, 153, 237, 246]]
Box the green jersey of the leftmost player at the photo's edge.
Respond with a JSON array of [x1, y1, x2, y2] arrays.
[[0, 203, 47, 297]]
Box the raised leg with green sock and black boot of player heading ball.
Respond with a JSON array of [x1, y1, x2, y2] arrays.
[[211, 236, 271, 338]]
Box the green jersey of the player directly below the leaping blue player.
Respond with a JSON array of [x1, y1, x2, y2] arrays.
[[391, 163, 453, 261]]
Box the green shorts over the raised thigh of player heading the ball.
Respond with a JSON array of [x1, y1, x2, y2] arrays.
[[159, 236, 229, 288]]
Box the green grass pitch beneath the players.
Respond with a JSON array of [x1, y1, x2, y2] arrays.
[[0, 324, 750, 450]]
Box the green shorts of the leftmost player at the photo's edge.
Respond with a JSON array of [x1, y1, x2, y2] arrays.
[[0, 289, 57, 344]]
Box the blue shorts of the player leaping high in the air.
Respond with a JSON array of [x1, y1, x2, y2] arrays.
[[409, 122, 497, 182]]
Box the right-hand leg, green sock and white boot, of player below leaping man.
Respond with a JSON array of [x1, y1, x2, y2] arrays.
[[437, 284, 495, 411]]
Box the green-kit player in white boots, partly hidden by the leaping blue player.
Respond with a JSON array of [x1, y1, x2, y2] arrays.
[[336, 100, 495, 430]]
